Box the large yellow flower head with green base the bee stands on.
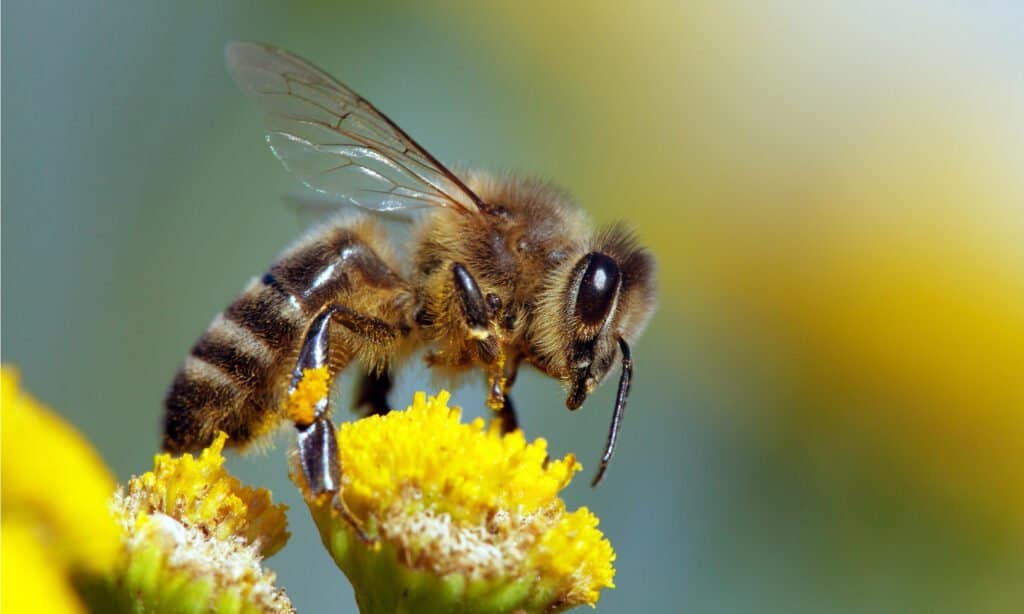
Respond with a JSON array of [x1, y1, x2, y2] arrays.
[[292, 391, 614, 612]]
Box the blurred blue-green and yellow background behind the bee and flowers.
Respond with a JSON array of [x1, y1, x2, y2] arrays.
[[2, 1, 1024, 613]]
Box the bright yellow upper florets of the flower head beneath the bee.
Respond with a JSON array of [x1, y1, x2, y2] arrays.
[[338, 391, 581, 522]]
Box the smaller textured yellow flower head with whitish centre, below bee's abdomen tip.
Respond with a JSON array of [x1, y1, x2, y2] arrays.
[[113, 434, 293, 612]]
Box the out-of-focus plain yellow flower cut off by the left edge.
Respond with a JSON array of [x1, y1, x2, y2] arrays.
[[0, 367, 121, 612]]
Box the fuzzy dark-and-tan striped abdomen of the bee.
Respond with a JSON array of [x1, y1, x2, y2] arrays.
[[164, 221, 412, 451]]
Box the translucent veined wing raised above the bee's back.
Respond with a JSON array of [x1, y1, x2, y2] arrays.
[[224, 43, 480, 213]]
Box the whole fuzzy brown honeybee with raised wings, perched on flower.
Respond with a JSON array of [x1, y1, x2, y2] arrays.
[[163, 43, 656, 493]]
